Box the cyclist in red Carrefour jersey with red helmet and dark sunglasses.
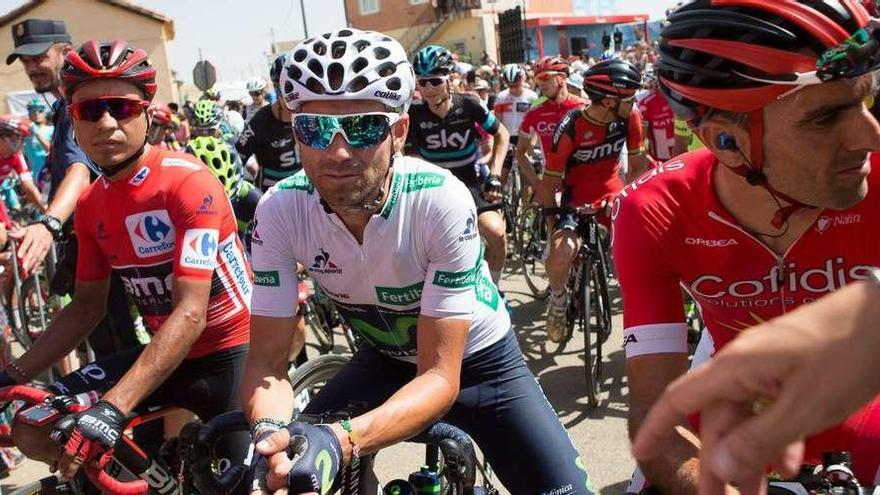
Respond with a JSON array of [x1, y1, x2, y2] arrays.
[[8, 40, 252, 478]]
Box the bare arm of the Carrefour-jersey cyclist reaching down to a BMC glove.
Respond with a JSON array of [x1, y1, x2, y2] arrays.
[[104, 277, 211, 414]]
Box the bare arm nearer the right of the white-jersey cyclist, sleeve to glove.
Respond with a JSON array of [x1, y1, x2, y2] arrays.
[[340, 315, 470, 461]]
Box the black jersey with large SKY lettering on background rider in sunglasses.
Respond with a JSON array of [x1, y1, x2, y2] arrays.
[[406, 93, 499, 169]]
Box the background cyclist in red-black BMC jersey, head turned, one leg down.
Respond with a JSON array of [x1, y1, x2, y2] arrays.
[[537, 59, 649, 342]]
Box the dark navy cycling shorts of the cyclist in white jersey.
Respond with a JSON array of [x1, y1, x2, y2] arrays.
[[305, 331, 595, 495]]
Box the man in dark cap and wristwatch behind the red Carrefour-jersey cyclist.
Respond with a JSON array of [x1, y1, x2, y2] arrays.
[[6, 19, 138, 356]]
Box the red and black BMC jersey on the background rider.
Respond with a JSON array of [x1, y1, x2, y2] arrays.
[[545, 108, 644, 206]]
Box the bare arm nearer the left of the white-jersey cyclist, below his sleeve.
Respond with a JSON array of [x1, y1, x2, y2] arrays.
[[239, 315, 300, 424]]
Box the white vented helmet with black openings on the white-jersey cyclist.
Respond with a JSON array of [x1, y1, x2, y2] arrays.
[[281, 28, 415, 114]]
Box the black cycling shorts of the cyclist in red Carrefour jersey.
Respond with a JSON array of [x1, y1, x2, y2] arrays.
[[50, 345, 248, 421]]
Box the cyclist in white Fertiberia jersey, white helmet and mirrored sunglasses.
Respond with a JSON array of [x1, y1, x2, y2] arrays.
[[241, 28, 594, 494]]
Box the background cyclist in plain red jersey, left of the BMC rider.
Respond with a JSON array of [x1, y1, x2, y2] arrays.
[[516, 57, 586, 190]]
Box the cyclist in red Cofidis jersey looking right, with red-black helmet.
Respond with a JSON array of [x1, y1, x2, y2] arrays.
[[613, 0, 880, 494]]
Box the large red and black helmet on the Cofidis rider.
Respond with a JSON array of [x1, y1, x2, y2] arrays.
[[655, 0, 869, 120]]
